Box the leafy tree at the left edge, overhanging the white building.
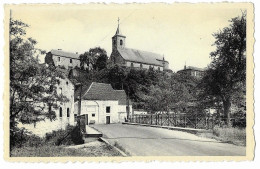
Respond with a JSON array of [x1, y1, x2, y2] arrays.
[[9, 19, 67, 148]]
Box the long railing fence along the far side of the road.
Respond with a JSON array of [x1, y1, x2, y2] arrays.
[[129, 113, 243, 129]]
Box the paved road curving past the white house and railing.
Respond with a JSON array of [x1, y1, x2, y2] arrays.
[[93, 124, 246, 156]]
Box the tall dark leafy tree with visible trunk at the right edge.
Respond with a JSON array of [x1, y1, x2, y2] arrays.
[[201, 13, 246, 126]]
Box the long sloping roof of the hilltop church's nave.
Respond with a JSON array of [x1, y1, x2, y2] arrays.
[[118, 48, 167, 66]]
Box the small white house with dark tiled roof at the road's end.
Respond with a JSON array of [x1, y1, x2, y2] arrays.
[[74, 82, 132, 124]]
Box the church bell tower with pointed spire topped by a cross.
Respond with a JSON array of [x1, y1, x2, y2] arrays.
[[112, 18, 126, 51]]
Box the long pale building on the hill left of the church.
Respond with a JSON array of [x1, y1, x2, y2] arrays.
[[45, 49, 91, 69]]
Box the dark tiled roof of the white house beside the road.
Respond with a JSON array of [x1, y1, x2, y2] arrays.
[[75, 82, 129, 105]]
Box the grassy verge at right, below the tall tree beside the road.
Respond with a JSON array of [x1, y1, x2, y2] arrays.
[[199, 127, 246, 146]]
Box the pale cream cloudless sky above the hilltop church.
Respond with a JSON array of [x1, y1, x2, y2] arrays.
[[11, 3, 243, 72]]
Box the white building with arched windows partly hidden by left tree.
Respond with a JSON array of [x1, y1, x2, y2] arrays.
[[18, 78, 75, 137]]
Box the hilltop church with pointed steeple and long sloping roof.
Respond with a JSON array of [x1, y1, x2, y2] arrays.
[[110, 19, 171, 71]]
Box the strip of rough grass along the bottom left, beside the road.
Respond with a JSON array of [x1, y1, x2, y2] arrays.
[[11, 143, 120, 157]]
